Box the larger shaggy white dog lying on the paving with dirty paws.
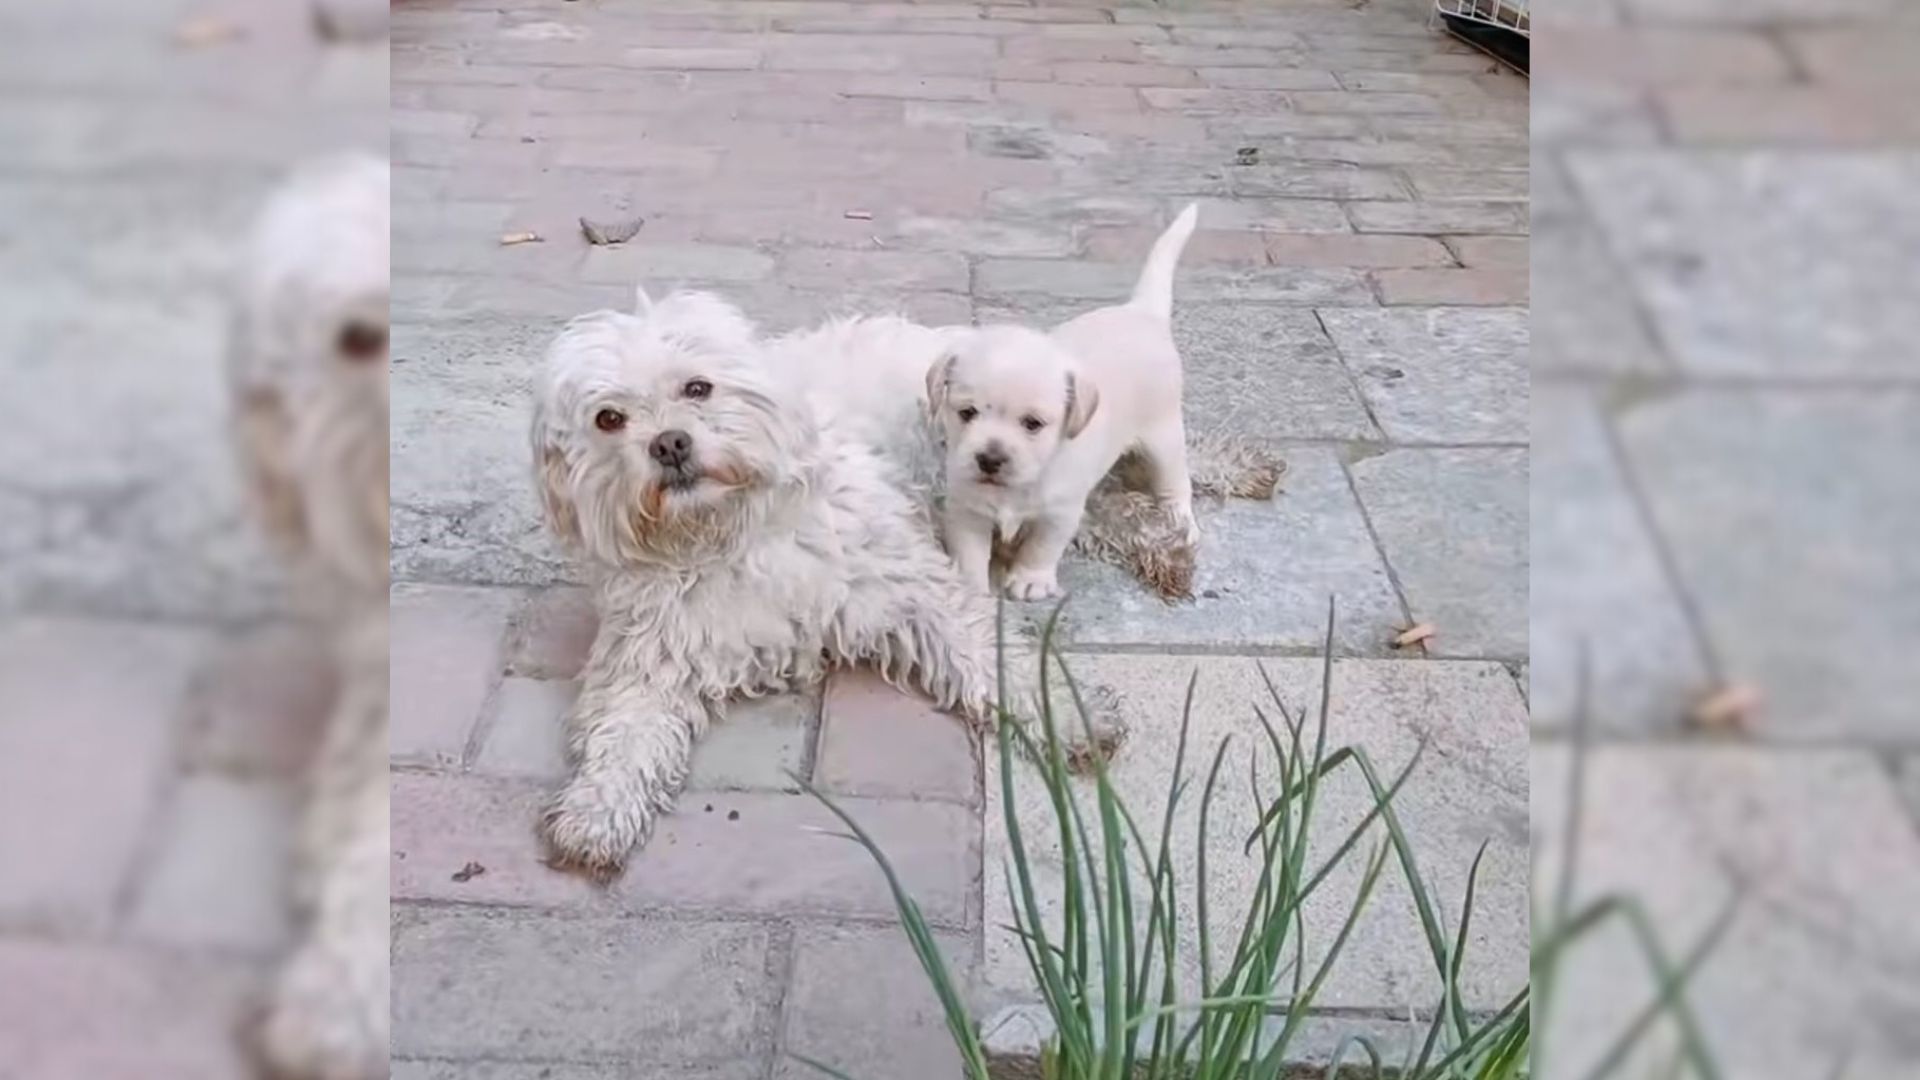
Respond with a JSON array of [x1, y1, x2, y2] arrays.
[[532, 292, 1098, 874]]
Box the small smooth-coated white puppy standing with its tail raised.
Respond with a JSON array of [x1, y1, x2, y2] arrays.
[[925, 206, 1200, 600]]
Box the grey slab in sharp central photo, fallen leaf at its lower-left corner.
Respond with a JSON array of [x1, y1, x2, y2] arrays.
[[1350, 448, 1528, 659]]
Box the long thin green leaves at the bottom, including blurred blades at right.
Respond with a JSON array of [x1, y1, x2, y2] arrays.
[[803, 603, 1716, 1080]]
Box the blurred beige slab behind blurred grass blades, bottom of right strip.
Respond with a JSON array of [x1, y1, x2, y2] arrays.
[[1532, 746, 1920, 1080]]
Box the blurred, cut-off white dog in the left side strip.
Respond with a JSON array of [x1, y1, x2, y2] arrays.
[[228, 158, 392, 1080]]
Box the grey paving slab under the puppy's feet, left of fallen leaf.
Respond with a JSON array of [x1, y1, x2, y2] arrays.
[[1029, 446, 1404, 653]]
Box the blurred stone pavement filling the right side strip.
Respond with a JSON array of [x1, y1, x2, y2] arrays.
[[1532, 0, 1920, 1078]]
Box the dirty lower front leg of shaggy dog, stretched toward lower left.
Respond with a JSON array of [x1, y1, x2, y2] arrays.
[[545, 676, 707, 876]]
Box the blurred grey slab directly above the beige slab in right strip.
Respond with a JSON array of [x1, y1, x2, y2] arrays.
[[1617, 390, 1920, 742]]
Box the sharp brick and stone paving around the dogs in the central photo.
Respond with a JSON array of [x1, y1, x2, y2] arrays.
[[394, 0, 1528, 1080]]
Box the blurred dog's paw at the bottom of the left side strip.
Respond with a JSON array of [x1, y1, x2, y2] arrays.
[[253, 930, 390, 1080]]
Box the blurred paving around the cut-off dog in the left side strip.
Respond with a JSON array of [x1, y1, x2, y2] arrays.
[[0, 0, 388, 1080]]
